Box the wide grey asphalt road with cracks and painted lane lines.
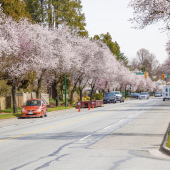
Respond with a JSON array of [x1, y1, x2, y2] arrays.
[[0, 98, 170, 170]]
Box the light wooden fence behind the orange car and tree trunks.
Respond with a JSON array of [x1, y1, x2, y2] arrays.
[[0, 92, 49, 110]]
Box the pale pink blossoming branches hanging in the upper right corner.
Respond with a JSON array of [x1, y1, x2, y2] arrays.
[[129, 0, 170, 30]]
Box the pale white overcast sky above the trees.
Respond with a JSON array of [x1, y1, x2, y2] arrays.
[[82, 0, 168, 63]]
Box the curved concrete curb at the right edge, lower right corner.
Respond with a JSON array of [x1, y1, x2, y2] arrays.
[[159, 123, 170, 156]]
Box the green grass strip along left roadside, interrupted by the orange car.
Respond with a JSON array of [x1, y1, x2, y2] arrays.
[[0, 106, 75, 120]]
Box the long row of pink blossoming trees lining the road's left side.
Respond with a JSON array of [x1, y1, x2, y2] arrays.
[[0, 5, 155, 113]]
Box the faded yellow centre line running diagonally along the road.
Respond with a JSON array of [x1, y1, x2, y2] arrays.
[[0, 102, 139, 142]]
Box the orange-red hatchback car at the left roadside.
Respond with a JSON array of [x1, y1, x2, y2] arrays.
[[21, 99, 47, 118]]
